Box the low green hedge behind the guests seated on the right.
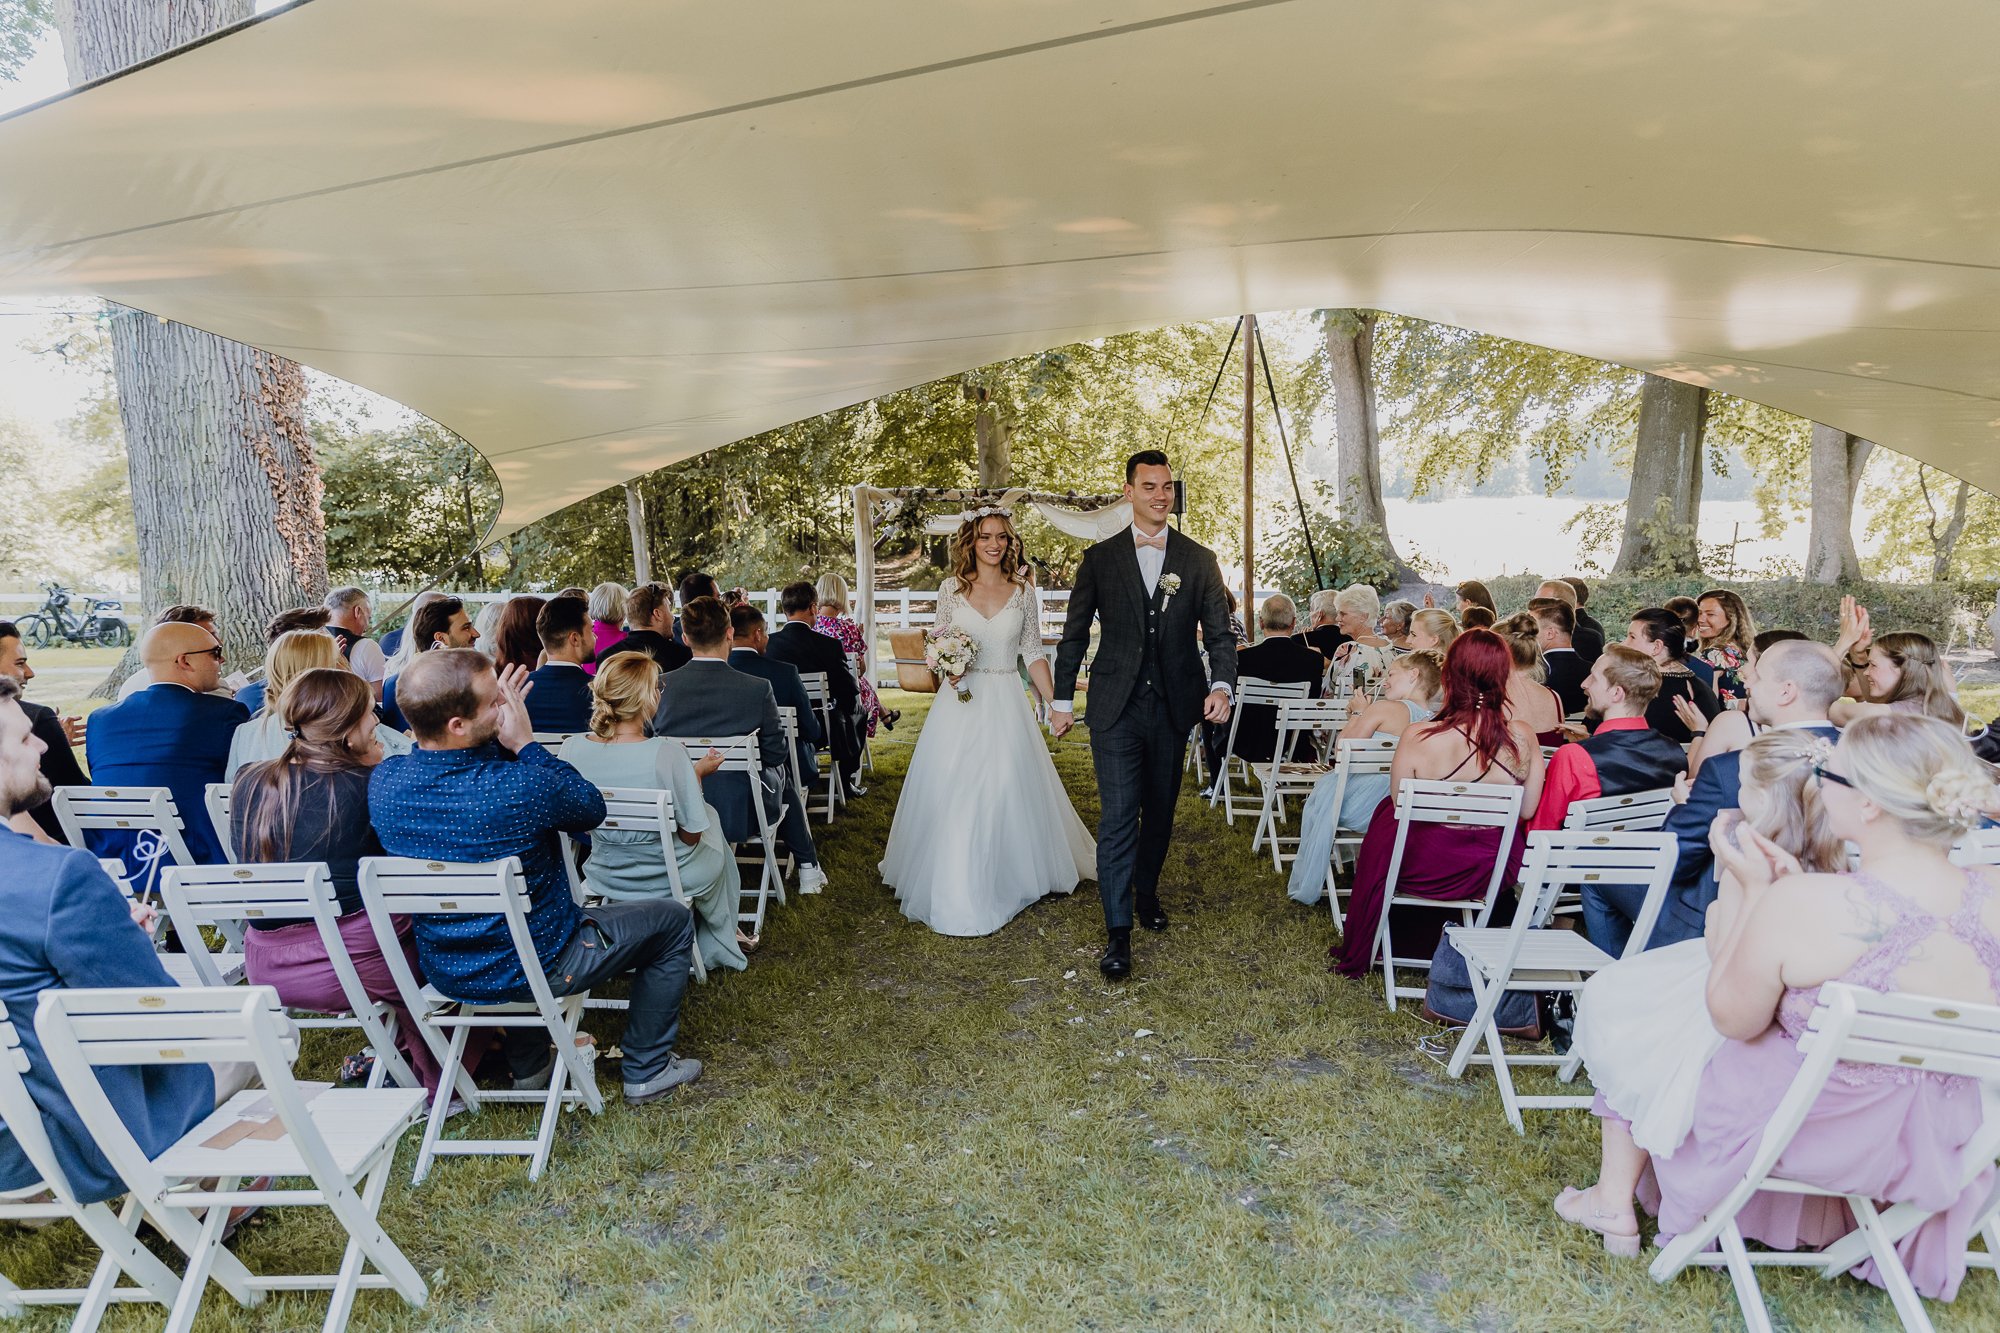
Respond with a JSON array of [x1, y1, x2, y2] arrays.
[[1484, 574, 1994, 644]]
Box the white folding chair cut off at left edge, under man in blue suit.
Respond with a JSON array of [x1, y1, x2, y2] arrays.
[[0, 1005, 180, 1329]]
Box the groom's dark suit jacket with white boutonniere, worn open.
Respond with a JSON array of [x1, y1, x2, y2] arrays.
[[1056, 528, 1236, 733]]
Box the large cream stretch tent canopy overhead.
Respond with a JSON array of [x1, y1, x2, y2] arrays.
[[0, 0, 2000, 528]]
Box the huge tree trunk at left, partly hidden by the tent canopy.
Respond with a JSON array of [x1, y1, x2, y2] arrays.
[[62, 0, 326, 689]]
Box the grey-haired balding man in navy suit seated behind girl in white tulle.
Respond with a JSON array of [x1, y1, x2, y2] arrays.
[[1584, 638, 1844, 957]]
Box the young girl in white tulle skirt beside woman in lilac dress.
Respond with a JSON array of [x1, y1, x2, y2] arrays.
[[1568, 728, 1848, 1153]]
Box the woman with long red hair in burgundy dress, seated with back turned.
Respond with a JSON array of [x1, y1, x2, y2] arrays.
[[1334, 628, 1542, 977]]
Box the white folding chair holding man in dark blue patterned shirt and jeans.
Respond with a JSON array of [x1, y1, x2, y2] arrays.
[[360, 857, 604, 1185]]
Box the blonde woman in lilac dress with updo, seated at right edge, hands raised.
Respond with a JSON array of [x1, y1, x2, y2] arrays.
[[1556, 715, 2000, 1301]]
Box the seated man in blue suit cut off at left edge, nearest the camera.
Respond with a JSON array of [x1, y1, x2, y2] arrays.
[[0, 680, 215, 1203]]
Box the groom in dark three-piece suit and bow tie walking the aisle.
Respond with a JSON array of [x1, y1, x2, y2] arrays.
[[1050, 448, 1236, 981]]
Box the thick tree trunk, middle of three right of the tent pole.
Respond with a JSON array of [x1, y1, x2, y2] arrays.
[[1612, 374, 1708, 576]]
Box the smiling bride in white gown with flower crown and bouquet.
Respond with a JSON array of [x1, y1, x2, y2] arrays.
[[882, 508, 1098, 935]]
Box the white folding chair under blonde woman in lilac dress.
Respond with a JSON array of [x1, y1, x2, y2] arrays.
[[1652, 981, 2000, 1333]]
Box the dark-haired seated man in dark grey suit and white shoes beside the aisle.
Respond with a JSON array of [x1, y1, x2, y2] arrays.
[[652, 596, 826, 893]]
